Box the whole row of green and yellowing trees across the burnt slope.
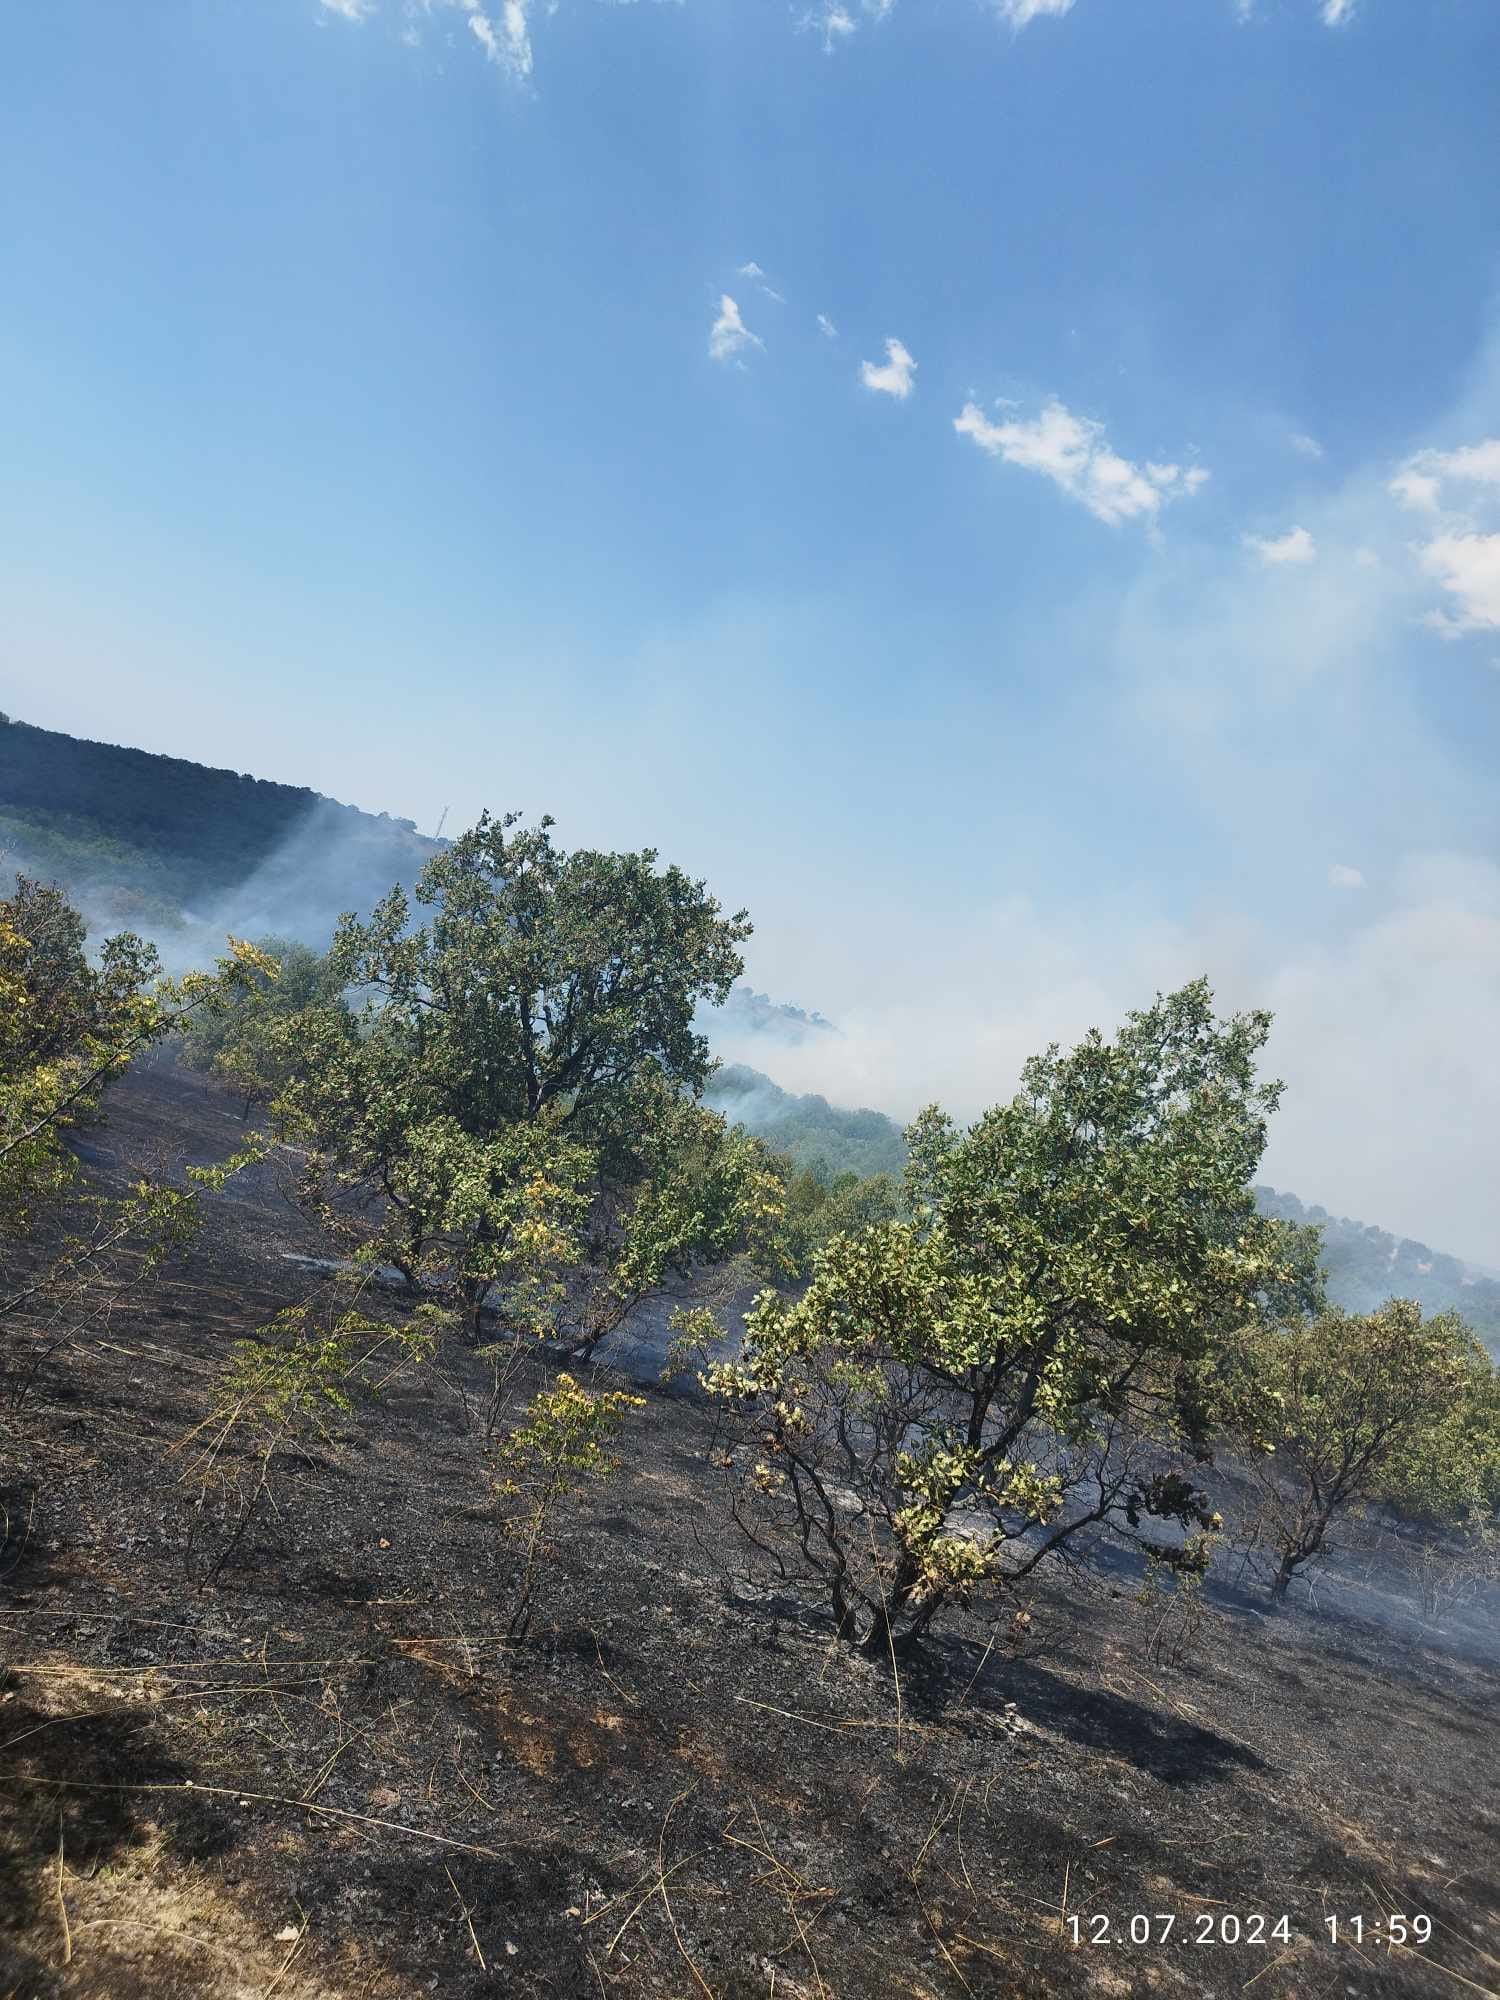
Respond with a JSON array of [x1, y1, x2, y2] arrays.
[[0, 814, 1500, 1656]]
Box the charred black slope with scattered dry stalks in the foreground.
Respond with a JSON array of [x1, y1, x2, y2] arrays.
[[0, 1066, 1500, 2000]]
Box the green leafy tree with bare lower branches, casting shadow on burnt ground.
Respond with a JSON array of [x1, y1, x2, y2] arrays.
[[704, 982, 1308, 1654]]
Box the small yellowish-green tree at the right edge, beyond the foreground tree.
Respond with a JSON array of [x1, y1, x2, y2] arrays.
[[1232, 1298, 1500, 1602]]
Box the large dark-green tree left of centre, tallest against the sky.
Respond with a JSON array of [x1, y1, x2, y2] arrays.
[[266, 814, 774, 1350]]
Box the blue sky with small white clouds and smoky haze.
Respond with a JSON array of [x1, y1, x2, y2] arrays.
[[0, 0, 1500, 1264]]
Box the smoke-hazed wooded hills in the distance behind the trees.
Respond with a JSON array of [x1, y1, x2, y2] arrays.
[[0, 714, 1500, 1352]]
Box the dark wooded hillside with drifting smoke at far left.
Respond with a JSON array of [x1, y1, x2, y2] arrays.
[[0, 716, 436, 954]]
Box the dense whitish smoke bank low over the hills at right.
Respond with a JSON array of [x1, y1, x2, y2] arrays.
[[710, 854, 1500, 1264]]
